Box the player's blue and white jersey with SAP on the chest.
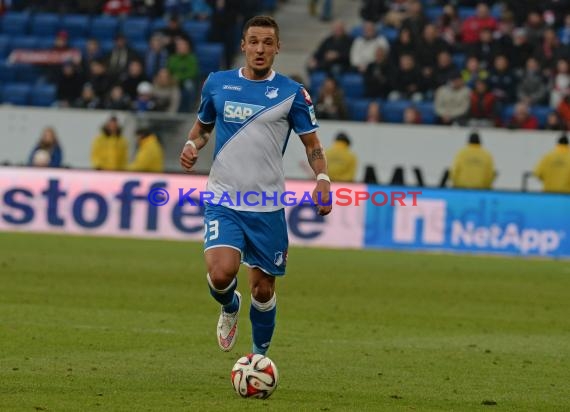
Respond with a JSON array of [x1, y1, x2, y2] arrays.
[[198, 69, 318, 212]]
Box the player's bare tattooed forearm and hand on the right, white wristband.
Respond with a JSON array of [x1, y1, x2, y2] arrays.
[[301, 132, 332, 216]]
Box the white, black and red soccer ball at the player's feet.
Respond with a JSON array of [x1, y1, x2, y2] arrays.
[[232, 353, 279, 399]]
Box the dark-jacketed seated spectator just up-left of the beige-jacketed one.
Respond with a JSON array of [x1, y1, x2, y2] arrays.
[[388, 54, 423, 102]]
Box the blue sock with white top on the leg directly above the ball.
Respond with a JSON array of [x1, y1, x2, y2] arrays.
[[249, 294, 277, 355]]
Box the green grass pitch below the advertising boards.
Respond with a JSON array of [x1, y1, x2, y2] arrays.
[[0, 233, 570, 412]]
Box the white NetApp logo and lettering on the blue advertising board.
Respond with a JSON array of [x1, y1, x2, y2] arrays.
[[393, 199, 564, 255]]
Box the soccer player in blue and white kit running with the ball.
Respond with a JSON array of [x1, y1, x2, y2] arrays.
[[180, 16, 332, 355]]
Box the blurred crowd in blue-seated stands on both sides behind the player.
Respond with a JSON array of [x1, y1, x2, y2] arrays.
[[0, 0, 570, 130]]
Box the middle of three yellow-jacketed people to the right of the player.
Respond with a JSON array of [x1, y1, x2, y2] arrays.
[[449, 133, 496, 189]]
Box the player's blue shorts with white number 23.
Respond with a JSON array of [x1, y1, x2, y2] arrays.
[[204, 204, 289, 276]]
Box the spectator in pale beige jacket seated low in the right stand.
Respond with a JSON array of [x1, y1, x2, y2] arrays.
[[434, 72, 471, 126]]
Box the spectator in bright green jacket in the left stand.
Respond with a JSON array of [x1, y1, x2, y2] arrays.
[[166, 38, 200, 112]]
